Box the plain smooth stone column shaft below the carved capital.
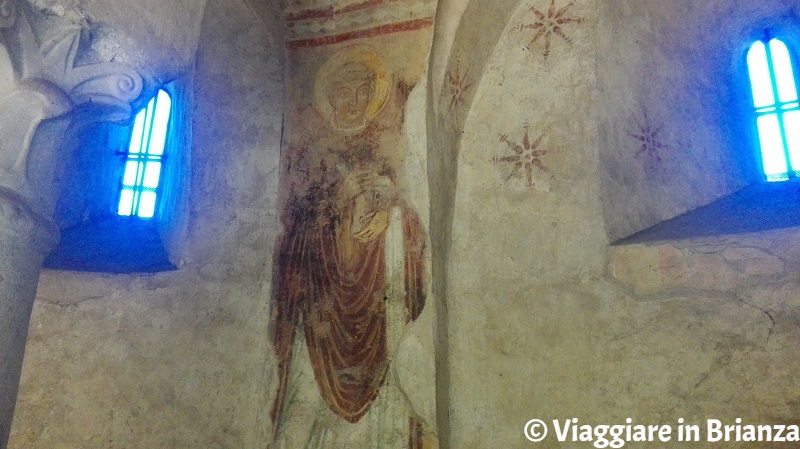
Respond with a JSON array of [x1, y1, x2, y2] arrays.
[[0, 190, 58, 448]]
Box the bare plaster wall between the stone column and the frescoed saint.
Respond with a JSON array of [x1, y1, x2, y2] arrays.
[[9, 2, 283, 449]]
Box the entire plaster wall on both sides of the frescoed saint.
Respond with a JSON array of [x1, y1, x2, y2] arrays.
[[11, 0, 800, 449]]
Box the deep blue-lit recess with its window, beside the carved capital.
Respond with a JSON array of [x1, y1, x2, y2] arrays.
[[44, 80, 186, 273]]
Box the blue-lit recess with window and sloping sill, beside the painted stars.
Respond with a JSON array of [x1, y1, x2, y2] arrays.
[[614, 29, 800, 245]]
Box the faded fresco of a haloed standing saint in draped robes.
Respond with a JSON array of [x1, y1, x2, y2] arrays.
[[272, 41, 436, 449]]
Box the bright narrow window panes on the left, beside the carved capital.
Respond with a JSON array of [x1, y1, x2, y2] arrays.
[[117, 90, 172, 218]]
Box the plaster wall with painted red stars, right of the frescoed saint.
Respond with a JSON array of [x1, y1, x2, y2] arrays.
[[440, 1, 800, 448]]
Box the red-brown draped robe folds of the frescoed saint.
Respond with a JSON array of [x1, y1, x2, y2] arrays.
[[272, 207, 425, 449]]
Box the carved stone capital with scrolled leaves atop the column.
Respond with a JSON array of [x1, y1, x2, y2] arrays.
[[0, 0, 144, 216]]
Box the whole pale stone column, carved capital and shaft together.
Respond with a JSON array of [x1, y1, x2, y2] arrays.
[[0, 0, 143, 449]]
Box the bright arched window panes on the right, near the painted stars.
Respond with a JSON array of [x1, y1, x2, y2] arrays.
[[747, 34, 800, 181]]
